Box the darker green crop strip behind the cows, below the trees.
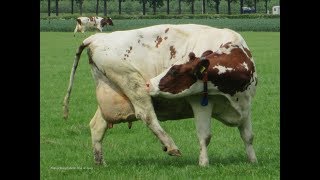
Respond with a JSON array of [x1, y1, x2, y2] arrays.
[[40, 18, 280, 32]]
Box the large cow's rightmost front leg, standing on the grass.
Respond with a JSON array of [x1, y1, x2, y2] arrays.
[[238, 112, 258, 163]]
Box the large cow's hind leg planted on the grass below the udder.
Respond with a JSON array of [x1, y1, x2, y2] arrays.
[[90, 107, 107, 165]]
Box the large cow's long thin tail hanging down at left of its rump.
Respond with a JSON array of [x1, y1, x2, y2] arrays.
[[63, 43, 90, 119]]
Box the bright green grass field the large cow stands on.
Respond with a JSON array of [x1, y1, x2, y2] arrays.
[[40, 32, 280, 179]]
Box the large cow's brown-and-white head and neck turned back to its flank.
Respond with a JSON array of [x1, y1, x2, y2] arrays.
[[149, 42, 256, 98]]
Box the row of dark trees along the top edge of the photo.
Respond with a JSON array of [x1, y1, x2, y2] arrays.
[[40, 0, 271, 16]]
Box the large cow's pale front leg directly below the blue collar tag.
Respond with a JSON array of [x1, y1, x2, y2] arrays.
[[189, 96, 212, 166]]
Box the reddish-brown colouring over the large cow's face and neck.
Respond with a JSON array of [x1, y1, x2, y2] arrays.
[[159, 43, 255, 96]]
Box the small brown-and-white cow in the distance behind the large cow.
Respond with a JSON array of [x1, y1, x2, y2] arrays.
[[73, 16, 113, 36]]
